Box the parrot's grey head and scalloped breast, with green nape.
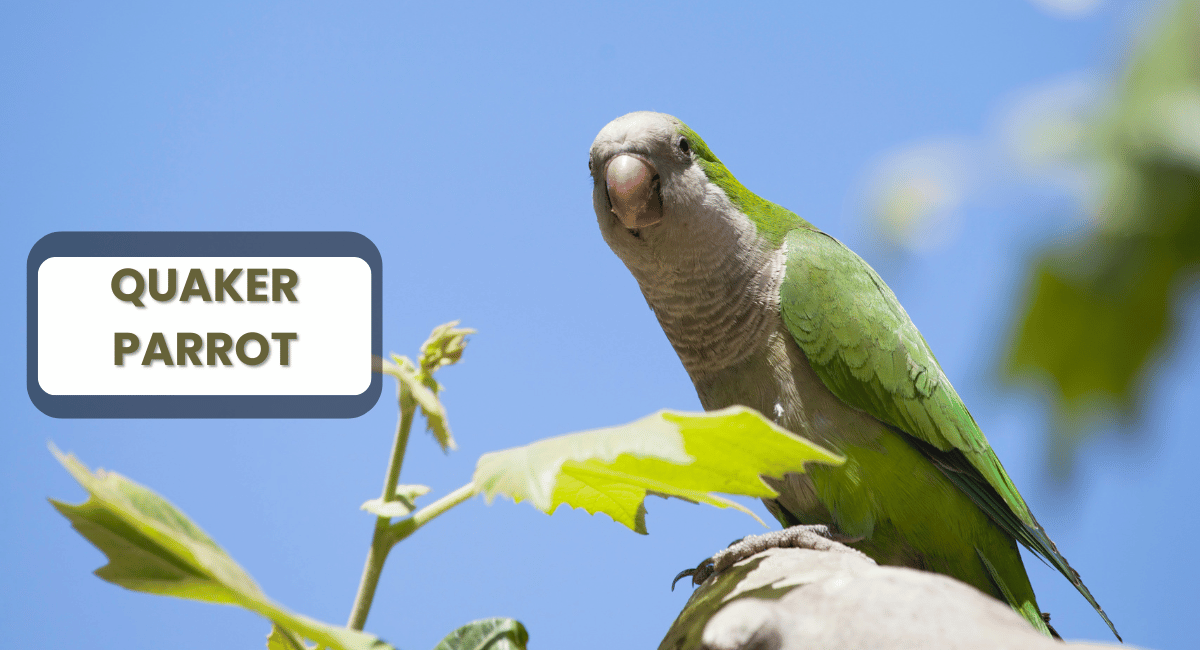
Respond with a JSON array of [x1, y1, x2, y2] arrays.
[[588, 112, 794, 378]]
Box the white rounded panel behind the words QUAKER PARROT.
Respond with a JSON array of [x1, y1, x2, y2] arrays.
[[37, 257, 372, 396]]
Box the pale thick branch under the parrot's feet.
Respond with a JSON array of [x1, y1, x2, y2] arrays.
[[659, 551, 1132, 650]]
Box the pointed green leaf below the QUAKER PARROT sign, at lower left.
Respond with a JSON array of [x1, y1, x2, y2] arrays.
[[50, 445, 391, 650]]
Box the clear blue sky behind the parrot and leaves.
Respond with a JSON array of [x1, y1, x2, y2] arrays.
[[0, 0, 1200, 649]]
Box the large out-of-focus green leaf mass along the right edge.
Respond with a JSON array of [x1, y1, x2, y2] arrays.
[[1006, 0, 1200, 468]]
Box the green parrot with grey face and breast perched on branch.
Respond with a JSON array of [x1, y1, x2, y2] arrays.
[[588, 112, 1121, 639]]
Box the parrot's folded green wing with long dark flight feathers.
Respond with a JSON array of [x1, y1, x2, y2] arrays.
[[780, 228, 1121, 639]]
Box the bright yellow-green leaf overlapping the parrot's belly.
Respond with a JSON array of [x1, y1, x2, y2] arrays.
[[473, 407, 842, 535]]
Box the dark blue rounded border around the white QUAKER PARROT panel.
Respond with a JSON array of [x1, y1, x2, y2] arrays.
[[25, 231, 383, 419]]
